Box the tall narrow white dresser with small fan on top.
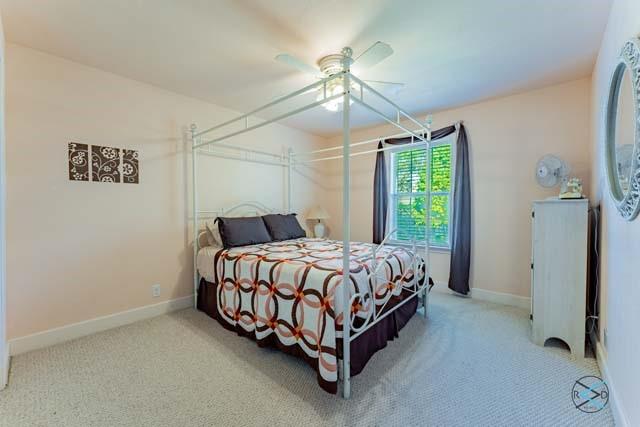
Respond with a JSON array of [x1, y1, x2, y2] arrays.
[[531, 199, 589, 358]]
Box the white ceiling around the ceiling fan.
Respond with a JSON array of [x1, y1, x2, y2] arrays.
[[0, 0, 610, 135]]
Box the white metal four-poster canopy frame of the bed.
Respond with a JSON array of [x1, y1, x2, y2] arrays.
[[191, 56, 431, 399]]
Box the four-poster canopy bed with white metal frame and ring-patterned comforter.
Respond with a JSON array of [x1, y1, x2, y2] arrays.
[[191, 48, 431, 398]]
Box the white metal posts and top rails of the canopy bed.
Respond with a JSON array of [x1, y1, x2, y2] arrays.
[[191, 67, 431, 399]]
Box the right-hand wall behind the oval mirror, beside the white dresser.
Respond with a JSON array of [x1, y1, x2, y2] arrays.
[[592, 0, 640, 426]]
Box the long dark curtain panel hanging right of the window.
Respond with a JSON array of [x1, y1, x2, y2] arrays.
[[449, 124, 471, 295]]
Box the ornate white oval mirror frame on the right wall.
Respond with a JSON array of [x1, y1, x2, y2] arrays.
[[605, 38, 640, 221]]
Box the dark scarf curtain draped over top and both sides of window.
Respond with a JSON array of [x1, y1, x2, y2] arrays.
[[373, 123, 471, 295]]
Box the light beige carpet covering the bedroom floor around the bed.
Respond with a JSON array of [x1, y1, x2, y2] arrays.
[[0, 292, 613, 427]]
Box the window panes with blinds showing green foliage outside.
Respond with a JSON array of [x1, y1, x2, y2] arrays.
[[389, 137, 453, 249]]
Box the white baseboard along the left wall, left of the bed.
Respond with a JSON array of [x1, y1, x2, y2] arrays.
[[9, 295, 193, 356]]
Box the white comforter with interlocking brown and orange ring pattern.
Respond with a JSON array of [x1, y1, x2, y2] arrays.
[[208, 238, 424, 390]]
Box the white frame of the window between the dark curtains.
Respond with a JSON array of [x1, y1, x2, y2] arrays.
[[387, 132, 457, 252]]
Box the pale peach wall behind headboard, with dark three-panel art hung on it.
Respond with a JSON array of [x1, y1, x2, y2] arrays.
[[7, 44, 323, 339]]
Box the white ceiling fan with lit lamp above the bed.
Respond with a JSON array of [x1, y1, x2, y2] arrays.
[[275, 41, 404, 111]]
